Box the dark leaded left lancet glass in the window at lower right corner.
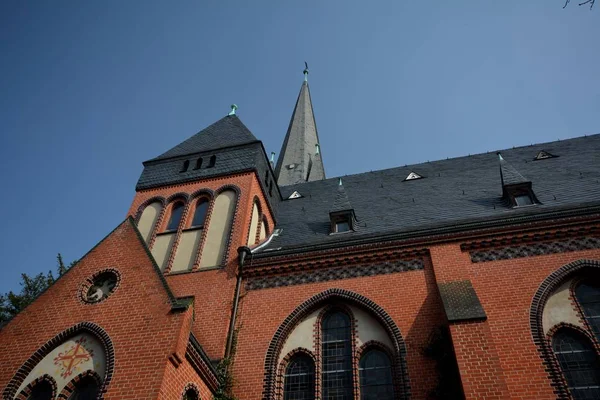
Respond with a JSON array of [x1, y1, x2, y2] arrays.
[[552, 329, 600, 400]]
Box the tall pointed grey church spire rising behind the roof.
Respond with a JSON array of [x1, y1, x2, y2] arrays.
[[275, 63, 325, 186]]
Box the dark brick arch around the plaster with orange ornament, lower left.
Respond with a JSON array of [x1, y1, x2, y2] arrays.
[[2, 322, 115, 400]]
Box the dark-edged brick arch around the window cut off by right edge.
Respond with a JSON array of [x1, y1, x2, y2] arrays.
[[529, 260, 600, 400]]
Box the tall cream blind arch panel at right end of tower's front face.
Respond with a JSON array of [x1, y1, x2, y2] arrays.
[[200, 190, 236, 268]]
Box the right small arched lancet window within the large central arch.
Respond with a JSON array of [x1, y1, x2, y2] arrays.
[[358, 349, 394, 400]]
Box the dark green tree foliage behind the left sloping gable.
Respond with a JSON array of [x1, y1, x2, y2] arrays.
[[0, 253, 76, 325]]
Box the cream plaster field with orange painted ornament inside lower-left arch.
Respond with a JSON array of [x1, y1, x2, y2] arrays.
[[17, 334, 106, 393]]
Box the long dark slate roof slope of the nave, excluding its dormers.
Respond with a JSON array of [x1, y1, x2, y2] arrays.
[[261, 135, 600, 252]]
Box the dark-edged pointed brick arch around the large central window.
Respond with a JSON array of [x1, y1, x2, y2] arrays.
[[262, 288, 410, 399]]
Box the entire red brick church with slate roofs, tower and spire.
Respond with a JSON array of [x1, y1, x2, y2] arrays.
[[0, 70, 600, 400]]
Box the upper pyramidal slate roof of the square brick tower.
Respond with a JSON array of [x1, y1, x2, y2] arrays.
[[150, 114, 258, 161]]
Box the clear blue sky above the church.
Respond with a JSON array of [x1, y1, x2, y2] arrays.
[[0, 0, 600, 292]]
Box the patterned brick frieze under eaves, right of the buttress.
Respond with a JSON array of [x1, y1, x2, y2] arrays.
[[470, 236, 600, 263]]
